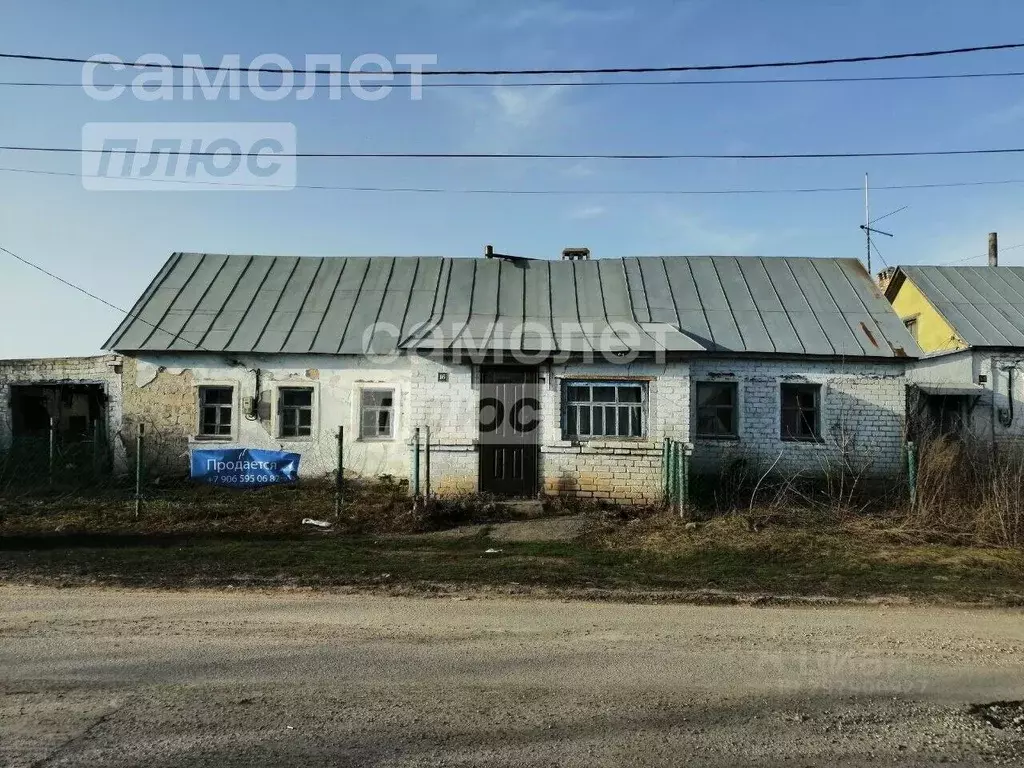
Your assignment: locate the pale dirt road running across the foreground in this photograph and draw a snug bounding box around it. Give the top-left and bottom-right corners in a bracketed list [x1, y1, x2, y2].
[0, 587, 1024, 768]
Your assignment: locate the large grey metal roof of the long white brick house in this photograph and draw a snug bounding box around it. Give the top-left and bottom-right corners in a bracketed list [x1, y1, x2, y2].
[103, 253, 921, 357]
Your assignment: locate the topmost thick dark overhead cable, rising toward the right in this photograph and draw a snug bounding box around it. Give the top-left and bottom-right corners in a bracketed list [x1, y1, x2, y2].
[0, 43, 1024, 77]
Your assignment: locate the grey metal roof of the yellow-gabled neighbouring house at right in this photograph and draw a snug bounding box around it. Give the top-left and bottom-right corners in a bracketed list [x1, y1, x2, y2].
[893, 266, 1024, 347]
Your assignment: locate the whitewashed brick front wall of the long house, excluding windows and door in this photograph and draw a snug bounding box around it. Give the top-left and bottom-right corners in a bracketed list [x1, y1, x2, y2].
[117, 355, 905, 503]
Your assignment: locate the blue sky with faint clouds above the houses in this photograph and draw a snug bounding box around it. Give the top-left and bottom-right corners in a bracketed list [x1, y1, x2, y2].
[0, 0, 1024, 357]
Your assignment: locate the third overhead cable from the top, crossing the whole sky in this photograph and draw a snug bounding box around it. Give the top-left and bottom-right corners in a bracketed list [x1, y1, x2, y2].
[8, 145, 1024, 160]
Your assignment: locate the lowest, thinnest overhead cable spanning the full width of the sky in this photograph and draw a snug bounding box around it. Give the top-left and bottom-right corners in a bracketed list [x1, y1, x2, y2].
[8, 166, 1024, 195]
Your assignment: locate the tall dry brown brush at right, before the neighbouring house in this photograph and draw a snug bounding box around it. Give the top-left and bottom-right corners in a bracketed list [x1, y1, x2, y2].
[903, 437, 1024, 547]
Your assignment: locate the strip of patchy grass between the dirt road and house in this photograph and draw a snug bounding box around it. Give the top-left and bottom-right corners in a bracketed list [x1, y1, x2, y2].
[0, 516, 1024, 604]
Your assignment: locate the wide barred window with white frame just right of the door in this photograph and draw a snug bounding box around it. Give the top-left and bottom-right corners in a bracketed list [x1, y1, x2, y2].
[562, 381, 647, 440]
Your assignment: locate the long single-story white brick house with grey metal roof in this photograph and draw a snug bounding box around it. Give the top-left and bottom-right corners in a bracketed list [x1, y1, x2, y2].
[104, 248, 920, 503]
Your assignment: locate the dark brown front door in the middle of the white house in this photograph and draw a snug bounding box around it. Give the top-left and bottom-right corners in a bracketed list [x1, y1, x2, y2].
[479, 367, 541, 497]
